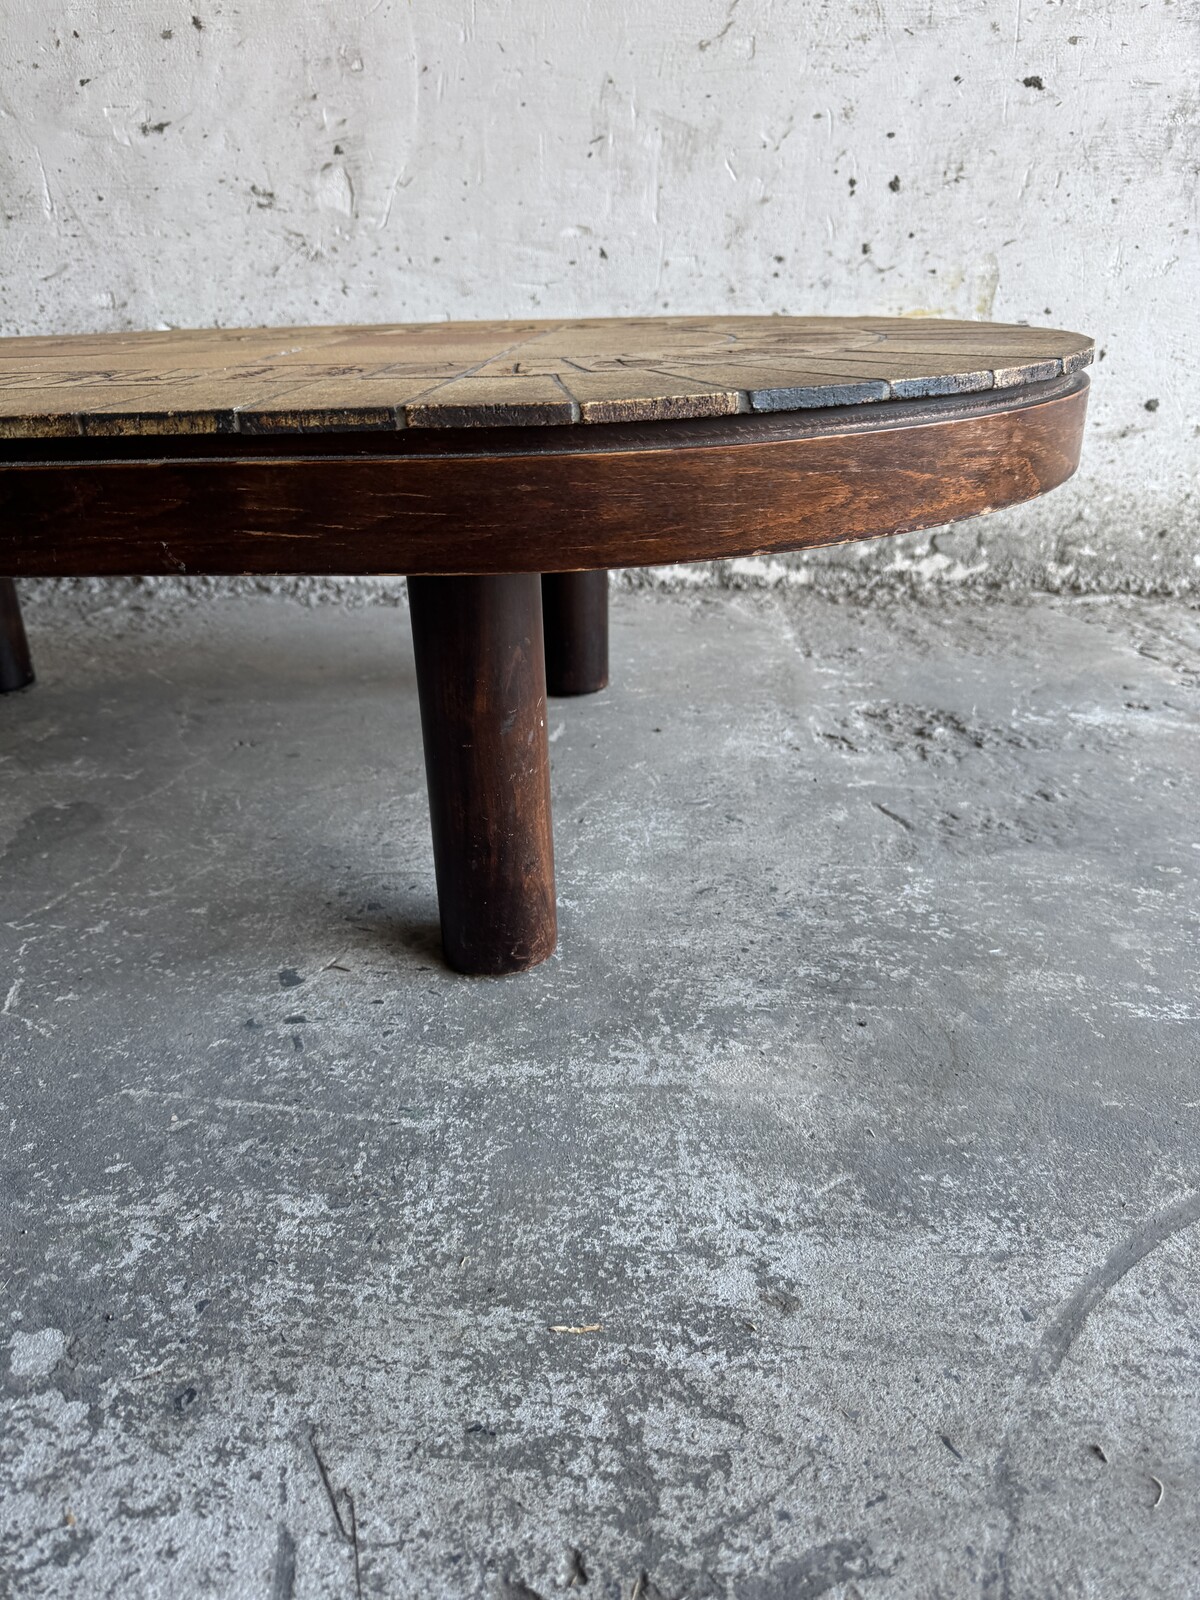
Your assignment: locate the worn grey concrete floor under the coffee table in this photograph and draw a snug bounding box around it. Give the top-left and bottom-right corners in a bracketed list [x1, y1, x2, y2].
[0, 594, 1200, 1600]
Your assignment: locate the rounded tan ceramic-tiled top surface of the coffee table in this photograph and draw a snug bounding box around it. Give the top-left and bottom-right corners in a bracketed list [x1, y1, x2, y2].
[0, 317, 1093, 438]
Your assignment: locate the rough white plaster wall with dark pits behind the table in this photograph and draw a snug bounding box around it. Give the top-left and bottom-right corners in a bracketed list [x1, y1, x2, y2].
[0, 0, 1200, 590]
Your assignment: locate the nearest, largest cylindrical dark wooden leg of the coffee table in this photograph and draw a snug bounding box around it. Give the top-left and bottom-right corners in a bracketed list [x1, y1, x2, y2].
[408, 573, 557, 973]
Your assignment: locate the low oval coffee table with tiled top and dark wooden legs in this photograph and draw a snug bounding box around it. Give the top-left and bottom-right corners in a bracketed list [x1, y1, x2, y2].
[0, 308, 1093, 973]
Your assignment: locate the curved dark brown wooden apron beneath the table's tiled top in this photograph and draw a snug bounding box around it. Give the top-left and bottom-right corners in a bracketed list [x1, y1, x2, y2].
[0, 374, 1086, 578]
